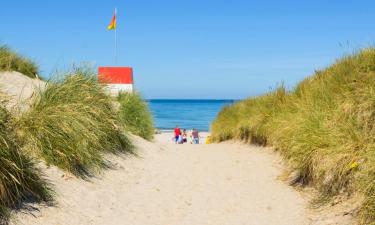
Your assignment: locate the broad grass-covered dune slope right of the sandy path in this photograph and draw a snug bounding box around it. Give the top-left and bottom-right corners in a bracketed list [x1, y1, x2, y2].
[212, 48, 375, 224]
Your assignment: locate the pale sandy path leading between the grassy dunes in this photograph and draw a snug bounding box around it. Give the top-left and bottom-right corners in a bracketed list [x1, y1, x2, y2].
[13, 134, 308, 225]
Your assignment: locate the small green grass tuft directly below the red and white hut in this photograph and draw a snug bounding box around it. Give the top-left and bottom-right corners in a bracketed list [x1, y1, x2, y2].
[117, 93, 154, 140]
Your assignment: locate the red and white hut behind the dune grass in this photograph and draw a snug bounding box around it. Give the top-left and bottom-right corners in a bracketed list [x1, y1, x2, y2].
[98, 66, 134, 96]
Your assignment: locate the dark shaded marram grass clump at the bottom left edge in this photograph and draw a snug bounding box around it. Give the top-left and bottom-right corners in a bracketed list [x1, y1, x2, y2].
[0, 106, 52, 224]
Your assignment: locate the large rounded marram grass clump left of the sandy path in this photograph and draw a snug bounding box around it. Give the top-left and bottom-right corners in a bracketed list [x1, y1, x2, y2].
[17, 69, 132, 177]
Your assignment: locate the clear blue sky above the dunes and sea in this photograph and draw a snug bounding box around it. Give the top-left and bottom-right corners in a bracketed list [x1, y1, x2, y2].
[0, 0, 375, 99]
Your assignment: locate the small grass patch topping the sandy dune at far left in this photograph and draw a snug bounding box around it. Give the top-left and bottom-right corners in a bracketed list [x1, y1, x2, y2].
[0, 45, 38, 78]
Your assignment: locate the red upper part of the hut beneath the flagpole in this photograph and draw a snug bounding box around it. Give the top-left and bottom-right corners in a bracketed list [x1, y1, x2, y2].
[98, 66, 133, 84]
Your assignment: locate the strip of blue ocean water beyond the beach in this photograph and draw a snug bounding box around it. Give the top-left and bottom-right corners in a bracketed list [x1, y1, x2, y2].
[148, 99, 234, 131]
